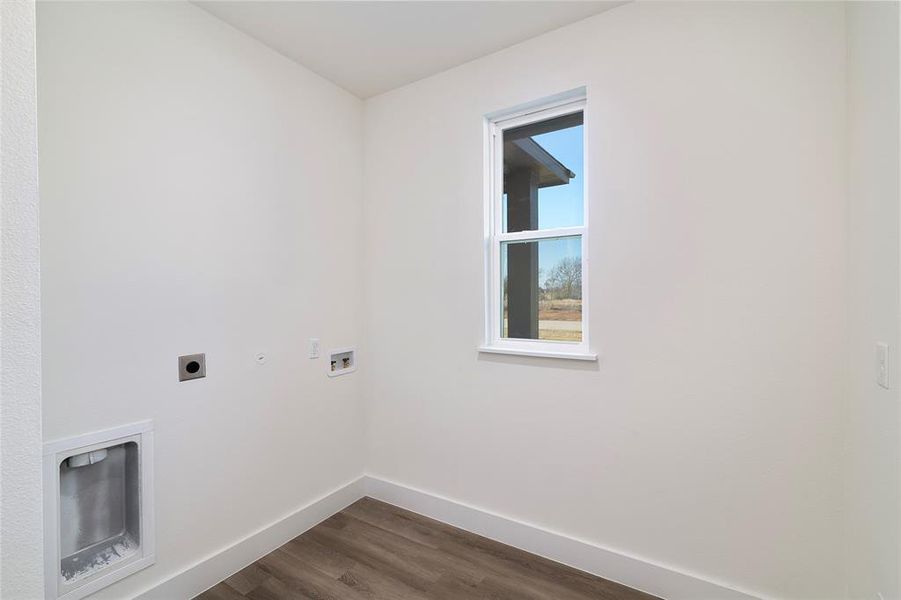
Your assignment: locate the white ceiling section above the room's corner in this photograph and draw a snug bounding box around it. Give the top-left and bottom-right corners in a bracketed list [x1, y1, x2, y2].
[196, 0, 623, 98]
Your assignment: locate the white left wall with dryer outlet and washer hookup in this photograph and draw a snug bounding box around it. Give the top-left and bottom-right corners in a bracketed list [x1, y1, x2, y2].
[38, 2, 363, 598]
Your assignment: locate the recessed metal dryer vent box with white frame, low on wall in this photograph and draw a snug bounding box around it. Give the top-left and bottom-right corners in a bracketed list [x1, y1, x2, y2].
[44, 421, 154, 600]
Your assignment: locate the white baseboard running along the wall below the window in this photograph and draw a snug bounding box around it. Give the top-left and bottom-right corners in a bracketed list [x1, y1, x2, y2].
[363, 475, 761, 600]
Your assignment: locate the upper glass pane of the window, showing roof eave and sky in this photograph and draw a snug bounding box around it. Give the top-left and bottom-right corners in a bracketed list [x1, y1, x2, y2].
[501, 112, 584, 232]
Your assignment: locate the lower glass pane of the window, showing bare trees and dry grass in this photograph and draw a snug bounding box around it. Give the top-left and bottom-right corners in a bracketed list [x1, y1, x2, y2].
[501, 235, 582, 342]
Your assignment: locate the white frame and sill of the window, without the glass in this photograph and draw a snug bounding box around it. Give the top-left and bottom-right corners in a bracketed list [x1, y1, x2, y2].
[479, 91, 597, 360]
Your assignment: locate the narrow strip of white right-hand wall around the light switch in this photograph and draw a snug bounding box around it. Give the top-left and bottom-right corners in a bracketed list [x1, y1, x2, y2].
[846, 2, 901, 599]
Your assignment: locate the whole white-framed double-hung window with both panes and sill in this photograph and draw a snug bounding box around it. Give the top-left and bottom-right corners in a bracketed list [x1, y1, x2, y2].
[481, 91, 596, 360]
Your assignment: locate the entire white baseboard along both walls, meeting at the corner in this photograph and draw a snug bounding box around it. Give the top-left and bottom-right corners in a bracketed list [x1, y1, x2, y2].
[137, 475, 762, 600]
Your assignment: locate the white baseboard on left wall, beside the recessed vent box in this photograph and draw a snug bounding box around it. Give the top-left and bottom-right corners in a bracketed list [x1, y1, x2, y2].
[137, 477, 365, 600]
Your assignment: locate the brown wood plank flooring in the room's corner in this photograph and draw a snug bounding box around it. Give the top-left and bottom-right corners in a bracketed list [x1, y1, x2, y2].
[197, 498, 655, 600]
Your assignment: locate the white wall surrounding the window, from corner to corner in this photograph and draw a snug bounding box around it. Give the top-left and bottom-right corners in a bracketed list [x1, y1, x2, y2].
[363, 3, 847, 600]
